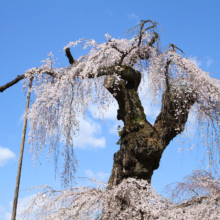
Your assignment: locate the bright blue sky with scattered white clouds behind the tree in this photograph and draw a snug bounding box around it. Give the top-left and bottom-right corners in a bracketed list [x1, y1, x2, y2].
[0, 0, 220, 220]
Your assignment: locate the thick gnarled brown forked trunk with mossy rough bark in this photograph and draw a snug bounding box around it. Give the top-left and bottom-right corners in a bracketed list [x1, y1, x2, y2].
[104, 66, 196, 187]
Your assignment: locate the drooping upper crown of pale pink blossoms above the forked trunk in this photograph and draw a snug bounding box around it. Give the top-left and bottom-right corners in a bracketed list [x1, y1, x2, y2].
[10, 20, 220, 185]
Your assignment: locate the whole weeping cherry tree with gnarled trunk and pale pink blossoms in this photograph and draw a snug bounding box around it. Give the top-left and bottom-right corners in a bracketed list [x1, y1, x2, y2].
[0, 20, 220, 219]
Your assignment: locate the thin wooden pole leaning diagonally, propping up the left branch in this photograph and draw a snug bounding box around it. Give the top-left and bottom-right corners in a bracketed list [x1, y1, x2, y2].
[11, 78, 33, 220]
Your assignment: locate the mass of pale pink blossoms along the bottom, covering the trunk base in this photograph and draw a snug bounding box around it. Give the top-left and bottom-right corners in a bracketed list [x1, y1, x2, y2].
[20, 171, 220, 220]
